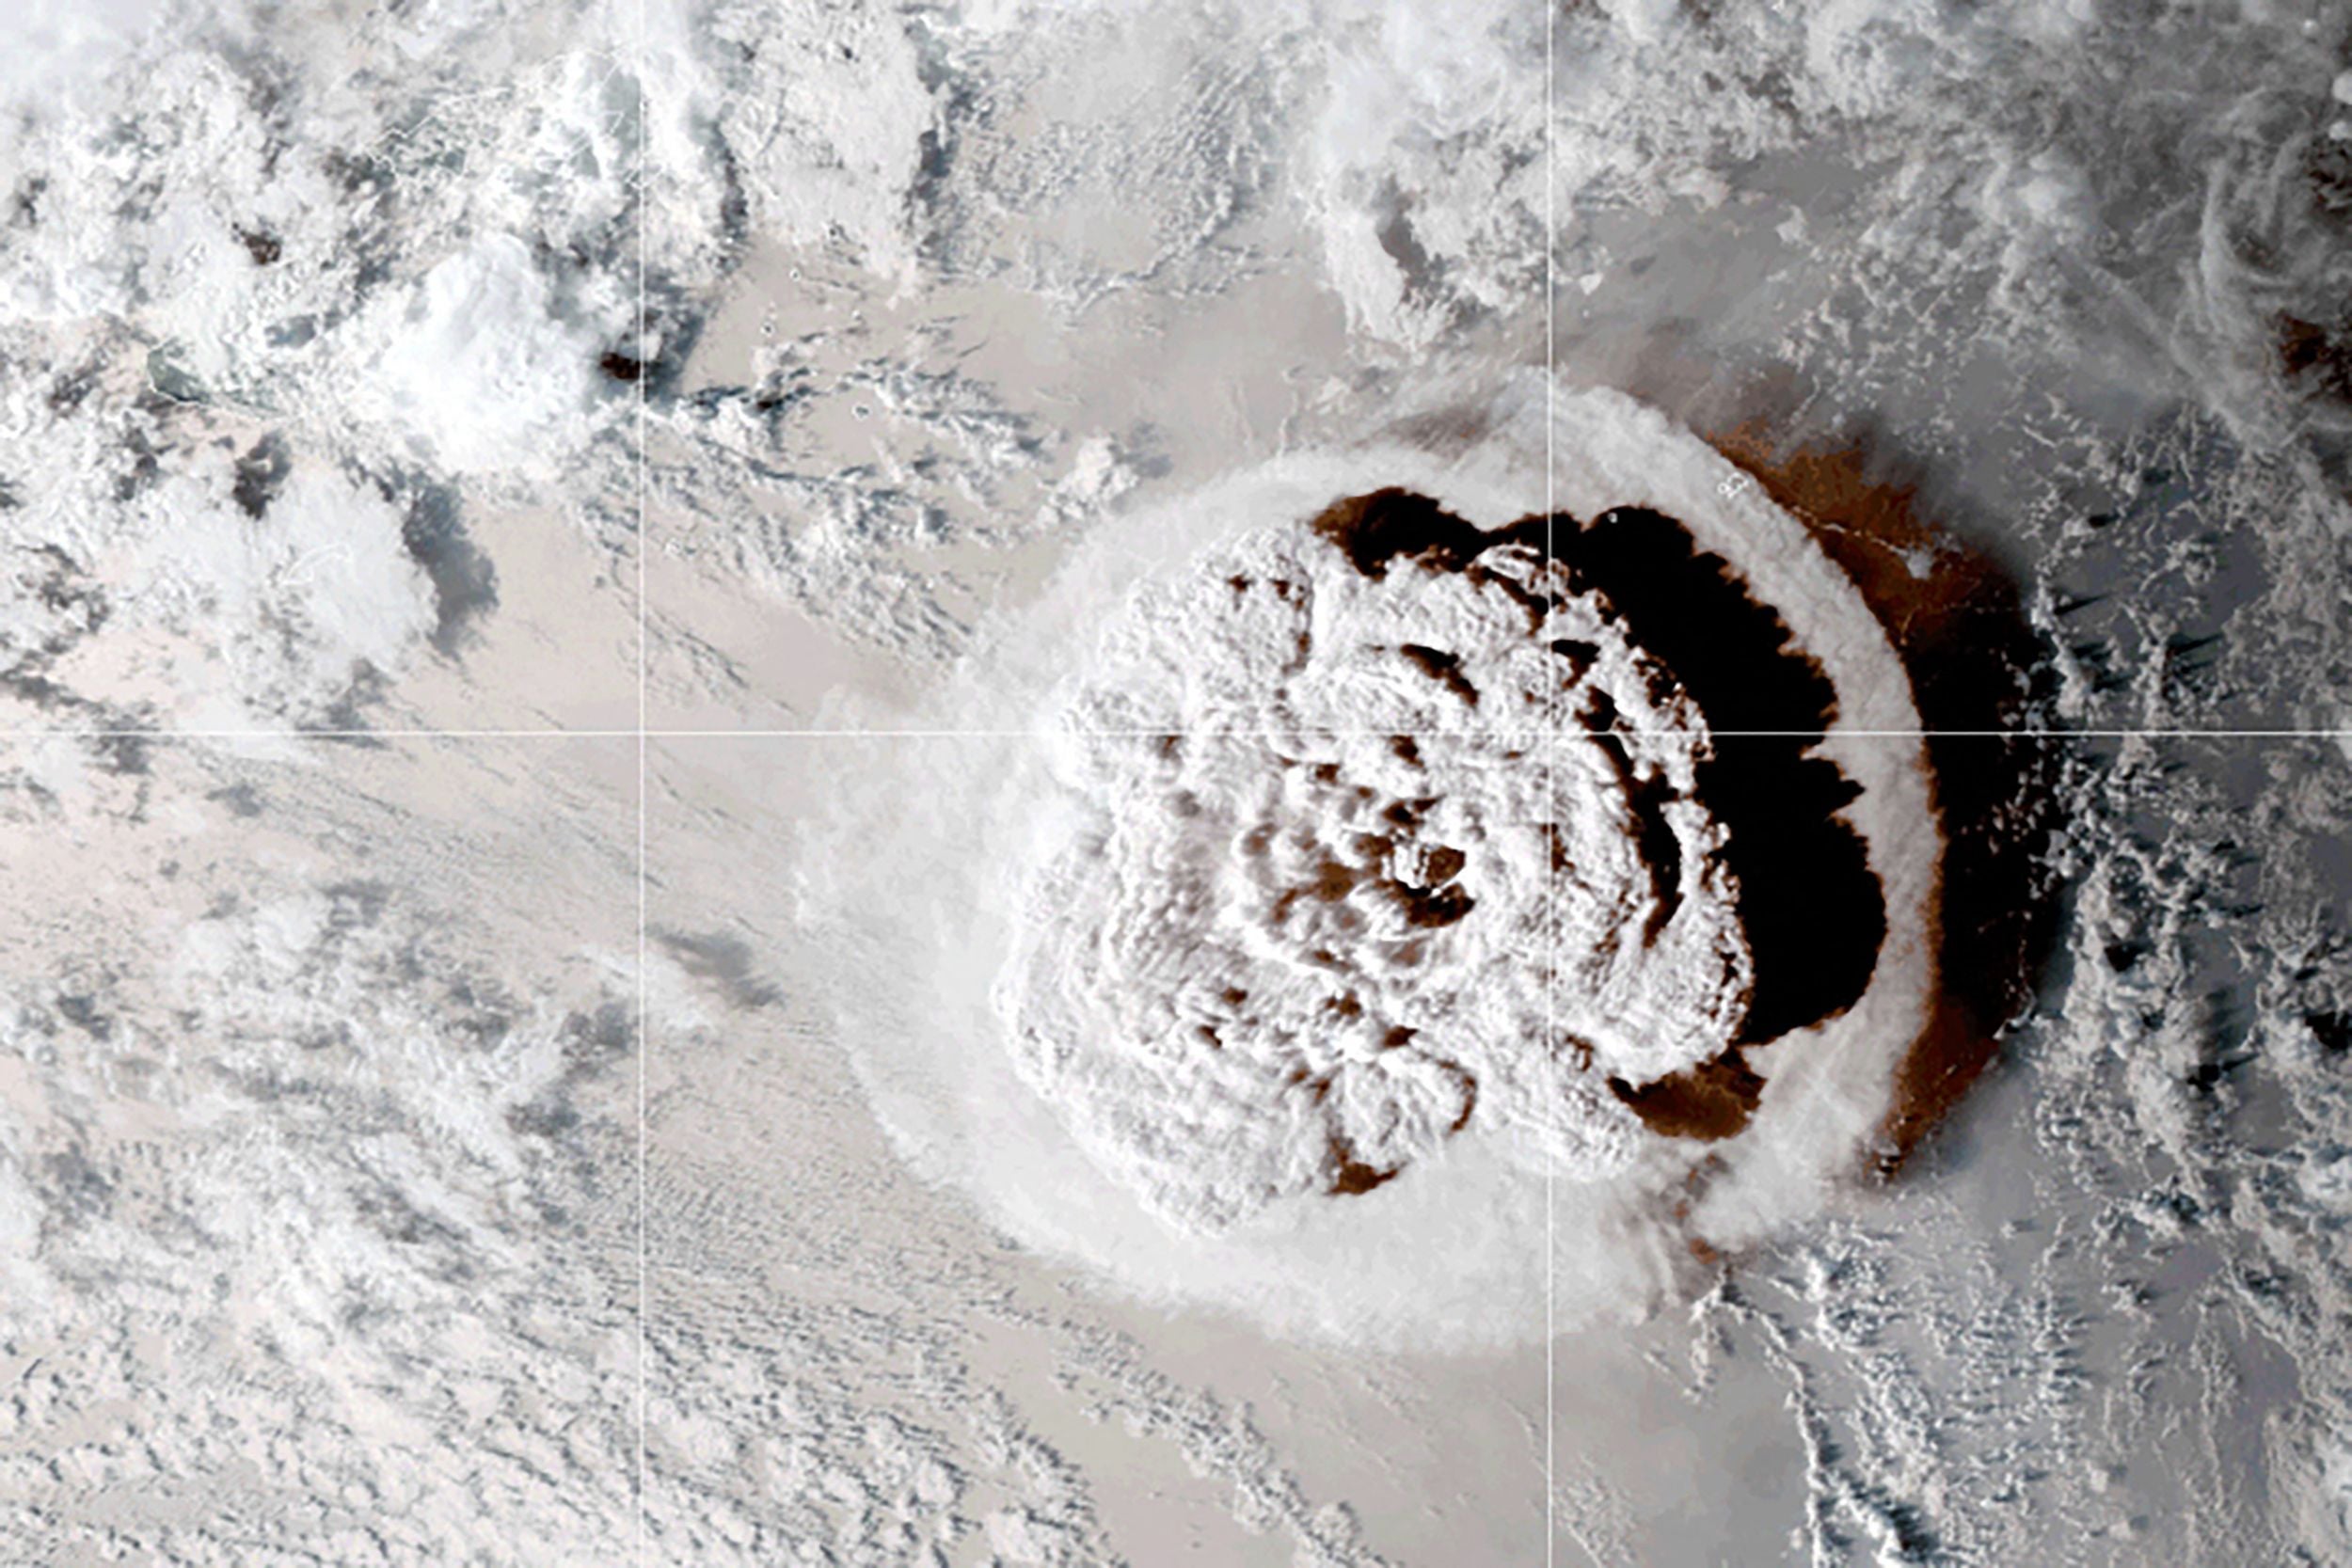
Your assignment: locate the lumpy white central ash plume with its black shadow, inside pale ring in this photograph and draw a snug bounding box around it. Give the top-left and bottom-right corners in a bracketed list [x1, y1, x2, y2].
[1002, 489, 1884, 1232]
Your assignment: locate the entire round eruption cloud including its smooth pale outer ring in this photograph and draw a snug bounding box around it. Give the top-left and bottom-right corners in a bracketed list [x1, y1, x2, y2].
[807, 383, 2023, 1345]
